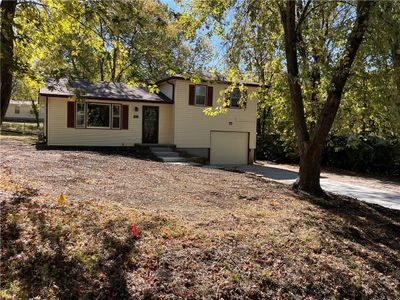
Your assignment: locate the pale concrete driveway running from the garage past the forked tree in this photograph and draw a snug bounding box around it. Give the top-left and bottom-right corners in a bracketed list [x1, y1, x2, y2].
[234, 165, 400, 210]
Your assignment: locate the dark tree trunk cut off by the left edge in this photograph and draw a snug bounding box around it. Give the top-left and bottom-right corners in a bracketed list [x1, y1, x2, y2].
[0, 0, 17, 125]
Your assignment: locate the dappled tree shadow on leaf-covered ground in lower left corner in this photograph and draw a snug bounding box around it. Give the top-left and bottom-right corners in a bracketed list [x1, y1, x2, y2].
[1, 189, 136, 299]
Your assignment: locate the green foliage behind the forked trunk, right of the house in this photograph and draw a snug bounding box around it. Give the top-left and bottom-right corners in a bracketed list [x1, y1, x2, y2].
[182, 0, 400, 178]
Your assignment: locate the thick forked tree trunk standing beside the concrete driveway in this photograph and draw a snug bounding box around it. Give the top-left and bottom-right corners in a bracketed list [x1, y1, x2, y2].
[281, 0, 375, 195]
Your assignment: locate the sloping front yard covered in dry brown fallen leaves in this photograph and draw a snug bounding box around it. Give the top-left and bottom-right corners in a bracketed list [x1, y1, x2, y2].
[0, 137, 400, 299]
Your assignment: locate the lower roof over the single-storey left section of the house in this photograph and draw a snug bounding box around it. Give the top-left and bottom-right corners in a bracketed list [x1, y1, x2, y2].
[39, 78, 173, 103]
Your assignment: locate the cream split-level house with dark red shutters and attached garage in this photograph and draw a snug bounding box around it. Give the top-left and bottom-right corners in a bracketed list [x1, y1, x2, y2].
[39, 75, 258, 164]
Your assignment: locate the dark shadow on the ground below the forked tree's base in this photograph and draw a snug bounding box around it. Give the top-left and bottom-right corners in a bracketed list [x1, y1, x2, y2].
[291, 191, 400, 277]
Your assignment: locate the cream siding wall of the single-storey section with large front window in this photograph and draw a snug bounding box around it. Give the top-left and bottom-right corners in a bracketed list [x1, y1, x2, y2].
[47, 97, 172, 146]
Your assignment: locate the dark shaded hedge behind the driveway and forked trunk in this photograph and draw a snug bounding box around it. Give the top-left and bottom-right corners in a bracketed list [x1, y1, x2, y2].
[257, 134, 400, 176]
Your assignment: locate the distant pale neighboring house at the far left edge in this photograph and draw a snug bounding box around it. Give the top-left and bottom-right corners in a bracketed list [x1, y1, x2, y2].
[4, 100, 43, 122]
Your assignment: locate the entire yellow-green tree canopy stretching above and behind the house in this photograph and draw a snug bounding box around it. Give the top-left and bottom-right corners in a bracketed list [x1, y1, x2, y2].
[2, 0, 400, 190]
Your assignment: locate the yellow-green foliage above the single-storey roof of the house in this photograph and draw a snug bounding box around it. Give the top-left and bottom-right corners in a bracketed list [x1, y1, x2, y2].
[9, 0, 210, 99]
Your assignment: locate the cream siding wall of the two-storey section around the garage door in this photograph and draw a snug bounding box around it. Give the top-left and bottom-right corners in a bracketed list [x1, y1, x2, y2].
[173, 80, 257, 149]
